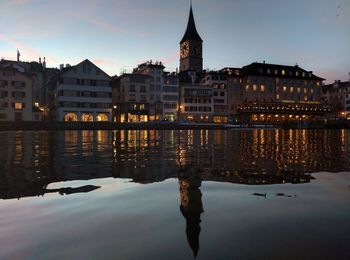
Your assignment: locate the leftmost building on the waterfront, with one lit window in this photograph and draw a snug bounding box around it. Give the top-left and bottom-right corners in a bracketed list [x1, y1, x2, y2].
[0, 67, 34, 122]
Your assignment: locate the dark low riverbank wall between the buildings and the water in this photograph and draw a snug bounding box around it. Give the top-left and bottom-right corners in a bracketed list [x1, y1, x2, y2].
[0, 122, 350, 131]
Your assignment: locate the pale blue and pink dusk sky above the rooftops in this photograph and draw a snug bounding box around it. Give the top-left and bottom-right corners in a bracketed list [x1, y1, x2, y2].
[0, 0, 350, 82]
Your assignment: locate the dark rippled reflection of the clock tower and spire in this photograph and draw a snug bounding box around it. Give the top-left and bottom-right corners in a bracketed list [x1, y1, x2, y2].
[179, 170, 203, 256]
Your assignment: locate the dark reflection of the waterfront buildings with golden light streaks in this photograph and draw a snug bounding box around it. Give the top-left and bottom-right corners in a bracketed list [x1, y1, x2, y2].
[0, 130, 350, 201]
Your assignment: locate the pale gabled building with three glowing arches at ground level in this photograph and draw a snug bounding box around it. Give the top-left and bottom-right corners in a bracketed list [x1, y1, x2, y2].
[50, 60, 112, 122]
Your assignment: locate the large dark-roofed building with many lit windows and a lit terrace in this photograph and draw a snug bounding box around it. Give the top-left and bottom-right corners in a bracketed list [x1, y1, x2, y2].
[237, 62, 329, 124]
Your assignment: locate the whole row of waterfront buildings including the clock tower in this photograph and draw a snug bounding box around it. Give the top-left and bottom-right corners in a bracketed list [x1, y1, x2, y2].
[0, 7, 350, 124]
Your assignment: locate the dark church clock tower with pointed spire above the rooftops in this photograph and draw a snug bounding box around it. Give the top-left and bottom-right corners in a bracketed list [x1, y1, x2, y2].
[180, 4, 203, 73]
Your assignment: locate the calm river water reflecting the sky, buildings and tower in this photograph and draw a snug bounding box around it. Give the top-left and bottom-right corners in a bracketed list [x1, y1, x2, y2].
[0, 129, 350, 259]
